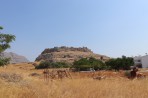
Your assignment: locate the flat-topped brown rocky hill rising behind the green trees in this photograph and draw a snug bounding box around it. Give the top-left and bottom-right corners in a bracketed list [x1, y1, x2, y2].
[36, 46, 110, 63]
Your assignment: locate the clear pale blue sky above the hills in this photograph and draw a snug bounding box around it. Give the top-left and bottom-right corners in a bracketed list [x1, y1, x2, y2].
[0, 0, 148, 61]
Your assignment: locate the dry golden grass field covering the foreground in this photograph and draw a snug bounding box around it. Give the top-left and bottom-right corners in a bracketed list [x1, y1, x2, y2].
[0, 63, 148, 98]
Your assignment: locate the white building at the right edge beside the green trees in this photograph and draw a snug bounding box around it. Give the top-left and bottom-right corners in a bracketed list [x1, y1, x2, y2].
[134, 55, 148, 68]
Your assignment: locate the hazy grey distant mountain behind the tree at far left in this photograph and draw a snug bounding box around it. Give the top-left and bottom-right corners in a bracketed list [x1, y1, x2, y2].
[0, 52, 29, 63]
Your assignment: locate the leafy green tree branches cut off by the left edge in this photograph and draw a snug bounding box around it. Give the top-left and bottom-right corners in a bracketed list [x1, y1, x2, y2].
[0, 26, 15, 66]
